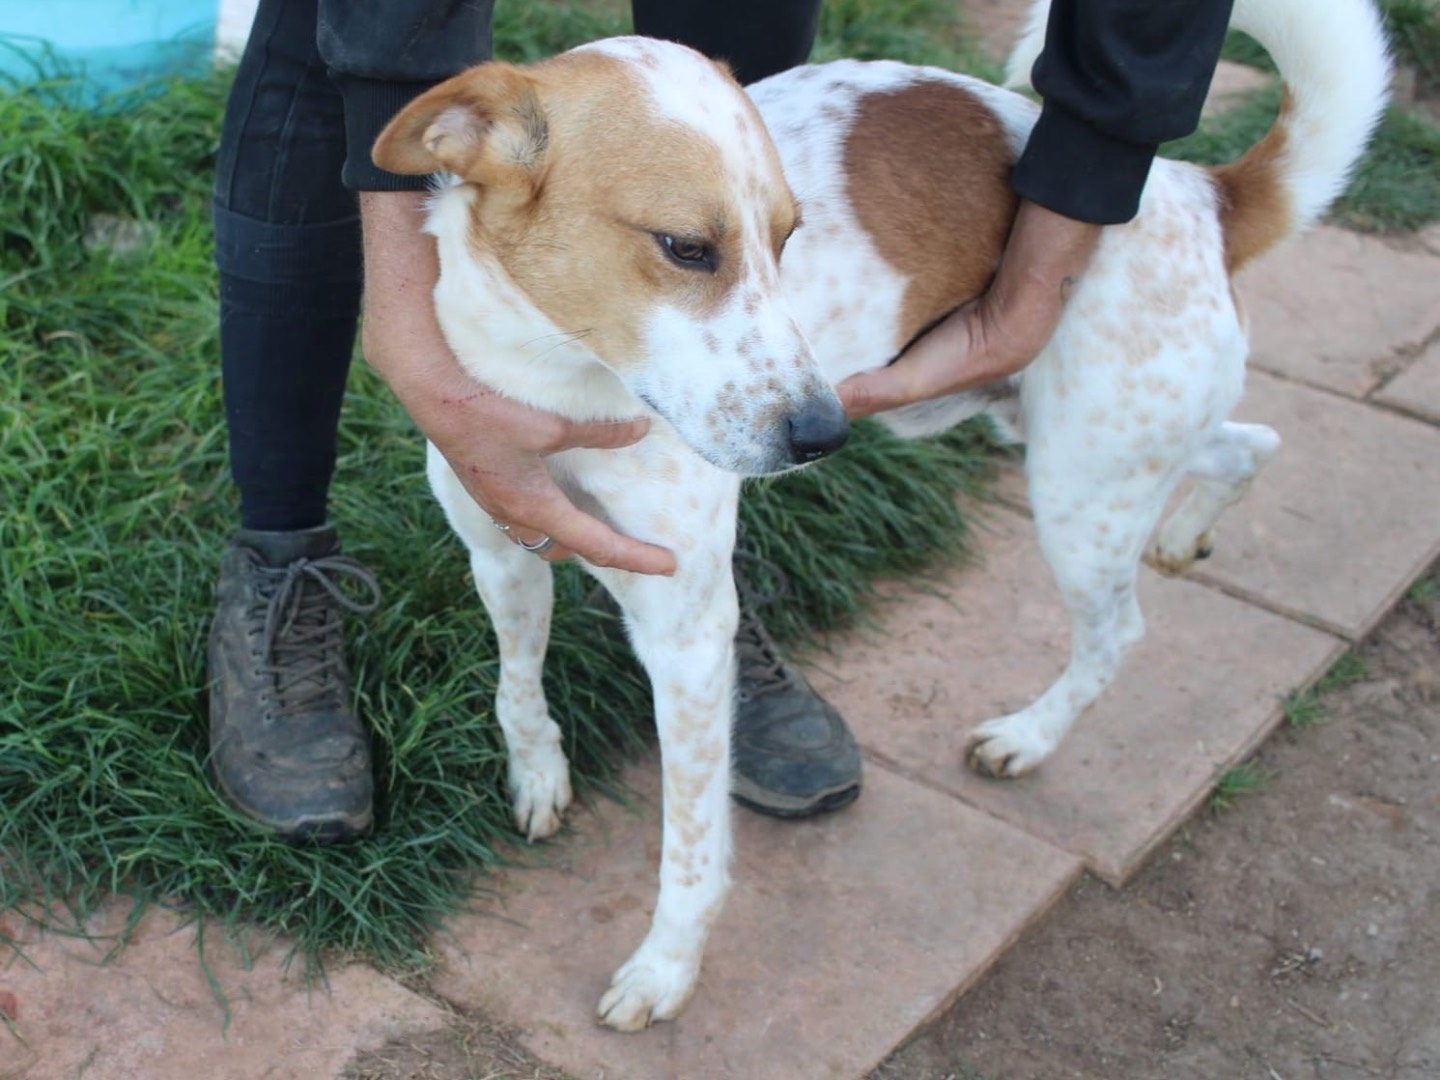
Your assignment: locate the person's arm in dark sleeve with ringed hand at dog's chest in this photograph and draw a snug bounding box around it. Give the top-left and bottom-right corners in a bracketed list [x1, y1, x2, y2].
[318, 0, 675, 573]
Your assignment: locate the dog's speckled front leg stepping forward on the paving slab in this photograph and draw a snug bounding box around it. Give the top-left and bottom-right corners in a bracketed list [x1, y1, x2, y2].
[587, 552, 739, 1031]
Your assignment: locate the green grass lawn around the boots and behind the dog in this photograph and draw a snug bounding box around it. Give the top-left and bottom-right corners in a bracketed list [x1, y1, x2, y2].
[0, 0, 1440, 968]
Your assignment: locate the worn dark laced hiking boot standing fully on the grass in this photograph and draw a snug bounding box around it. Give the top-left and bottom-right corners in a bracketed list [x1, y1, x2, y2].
[207, 526, 380, 841]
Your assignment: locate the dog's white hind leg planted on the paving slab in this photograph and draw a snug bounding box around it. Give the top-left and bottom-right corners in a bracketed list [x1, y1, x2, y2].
[965, 445, 1179, 776]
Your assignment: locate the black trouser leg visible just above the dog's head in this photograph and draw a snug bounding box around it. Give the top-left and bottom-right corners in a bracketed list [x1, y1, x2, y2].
[631, 0, 821, 84]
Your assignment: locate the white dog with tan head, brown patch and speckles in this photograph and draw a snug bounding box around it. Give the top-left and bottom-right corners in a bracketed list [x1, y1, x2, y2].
[373, 0, 1388, 1031]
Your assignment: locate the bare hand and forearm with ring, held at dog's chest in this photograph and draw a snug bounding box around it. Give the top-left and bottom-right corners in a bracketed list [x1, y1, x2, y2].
[360, 192, 675, 575]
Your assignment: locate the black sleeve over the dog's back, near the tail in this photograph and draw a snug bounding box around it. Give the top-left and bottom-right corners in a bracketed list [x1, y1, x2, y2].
[1014, 0, 1233, 225]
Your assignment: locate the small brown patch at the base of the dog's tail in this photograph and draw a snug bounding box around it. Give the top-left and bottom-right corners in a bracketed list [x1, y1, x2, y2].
[1211, 91, 1293, 274]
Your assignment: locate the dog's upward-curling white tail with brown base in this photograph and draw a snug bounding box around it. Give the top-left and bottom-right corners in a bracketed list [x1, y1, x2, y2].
[1005, 0, 1390, 272]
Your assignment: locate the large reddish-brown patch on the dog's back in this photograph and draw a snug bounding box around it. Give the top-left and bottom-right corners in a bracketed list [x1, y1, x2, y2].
[845, 79, 1017, 341]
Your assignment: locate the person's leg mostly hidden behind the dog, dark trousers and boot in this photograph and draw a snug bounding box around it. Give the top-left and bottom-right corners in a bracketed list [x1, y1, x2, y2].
[632, 0, 861, 818]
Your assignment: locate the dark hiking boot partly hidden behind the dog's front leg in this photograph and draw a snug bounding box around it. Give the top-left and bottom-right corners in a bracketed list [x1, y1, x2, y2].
[730, 547, 861, 818]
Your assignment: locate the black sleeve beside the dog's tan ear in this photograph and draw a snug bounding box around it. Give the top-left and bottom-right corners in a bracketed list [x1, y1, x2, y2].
[315, 0, 494, 192]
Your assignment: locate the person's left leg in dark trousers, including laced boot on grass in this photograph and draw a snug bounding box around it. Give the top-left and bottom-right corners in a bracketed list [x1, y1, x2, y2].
[209, 0, 374, 840]
